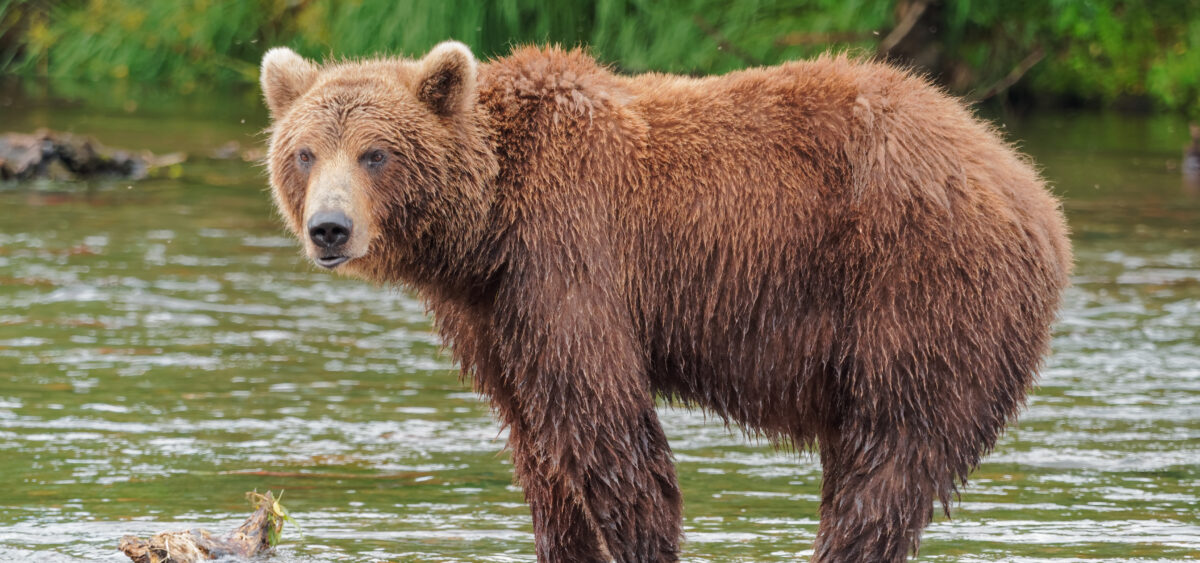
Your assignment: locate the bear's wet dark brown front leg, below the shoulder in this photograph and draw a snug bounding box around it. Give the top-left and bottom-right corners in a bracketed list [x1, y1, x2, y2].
[493, 286, 682, 563]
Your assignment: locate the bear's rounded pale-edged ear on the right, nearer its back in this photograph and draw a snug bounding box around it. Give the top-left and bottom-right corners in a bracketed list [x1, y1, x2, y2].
[416, 41, 476, 115]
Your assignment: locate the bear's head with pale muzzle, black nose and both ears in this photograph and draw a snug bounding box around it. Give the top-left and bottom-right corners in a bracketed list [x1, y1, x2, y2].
[260, 42, 497, 282]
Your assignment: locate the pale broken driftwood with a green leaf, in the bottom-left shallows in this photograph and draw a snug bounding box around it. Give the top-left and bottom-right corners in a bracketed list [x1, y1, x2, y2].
[118, 492, 295, 563]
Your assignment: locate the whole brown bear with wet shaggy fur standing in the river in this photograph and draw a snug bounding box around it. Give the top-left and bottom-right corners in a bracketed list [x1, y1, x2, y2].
[262, 42, 1072, 562]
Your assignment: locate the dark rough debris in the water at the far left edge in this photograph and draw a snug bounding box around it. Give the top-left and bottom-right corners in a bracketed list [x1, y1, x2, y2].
[0, 130, 186, 180]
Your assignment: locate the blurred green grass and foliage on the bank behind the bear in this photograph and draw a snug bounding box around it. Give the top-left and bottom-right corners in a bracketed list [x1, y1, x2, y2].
[0, 0, 1200, 116]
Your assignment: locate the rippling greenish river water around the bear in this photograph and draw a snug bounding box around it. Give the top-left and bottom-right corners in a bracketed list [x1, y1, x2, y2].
[0, 104, 1200, 562]
